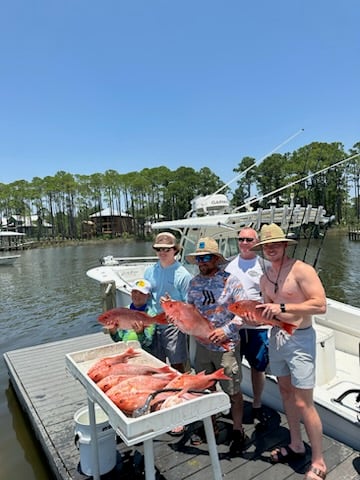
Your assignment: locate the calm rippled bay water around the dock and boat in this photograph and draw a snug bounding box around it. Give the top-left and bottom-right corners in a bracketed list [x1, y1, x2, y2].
[0, 231, 360, 480]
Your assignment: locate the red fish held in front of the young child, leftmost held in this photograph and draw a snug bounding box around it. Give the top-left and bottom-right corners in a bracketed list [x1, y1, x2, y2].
[98, 307, 168, 330]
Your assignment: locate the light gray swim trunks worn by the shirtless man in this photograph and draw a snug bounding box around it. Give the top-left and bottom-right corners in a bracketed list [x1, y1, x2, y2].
[269, 327, 316, 389]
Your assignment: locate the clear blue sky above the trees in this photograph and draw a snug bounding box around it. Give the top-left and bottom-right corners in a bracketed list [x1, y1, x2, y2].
[0, 0, 360, 191]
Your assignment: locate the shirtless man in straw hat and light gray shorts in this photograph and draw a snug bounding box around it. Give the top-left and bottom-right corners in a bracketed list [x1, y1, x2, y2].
[248, 224, 326, 480]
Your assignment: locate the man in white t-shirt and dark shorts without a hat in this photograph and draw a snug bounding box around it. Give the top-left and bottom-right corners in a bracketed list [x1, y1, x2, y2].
[225, 227, 271, 429]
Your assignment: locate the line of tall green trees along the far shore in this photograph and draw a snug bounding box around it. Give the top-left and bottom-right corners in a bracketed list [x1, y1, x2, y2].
[0, 142, 360, 239]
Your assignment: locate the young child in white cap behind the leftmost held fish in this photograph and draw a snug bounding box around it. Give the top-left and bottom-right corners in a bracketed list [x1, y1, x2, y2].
[109, 278, 155, 351]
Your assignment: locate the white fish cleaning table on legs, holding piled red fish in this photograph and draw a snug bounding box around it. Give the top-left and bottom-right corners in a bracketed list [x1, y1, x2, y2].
[66, 342, 230, 480]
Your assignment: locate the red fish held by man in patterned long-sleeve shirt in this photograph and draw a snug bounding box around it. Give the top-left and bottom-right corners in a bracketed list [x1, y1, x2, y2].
[161, 299, 230, 350]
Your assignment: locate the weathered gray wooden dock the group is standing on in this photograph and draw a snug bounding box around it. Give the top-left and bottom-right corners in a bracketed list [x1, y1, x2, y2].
[4, 333, 360, 480]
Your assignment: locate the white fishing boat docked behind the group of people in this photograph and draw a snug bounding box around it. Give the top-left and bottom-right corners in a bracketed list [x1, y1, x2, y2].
[86, 195, 360, 450]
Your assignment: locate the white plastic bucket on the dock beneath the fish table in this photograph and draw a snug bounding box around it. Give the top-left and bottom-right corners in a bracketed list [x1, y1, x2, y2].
[74, 404, 116, 476]
